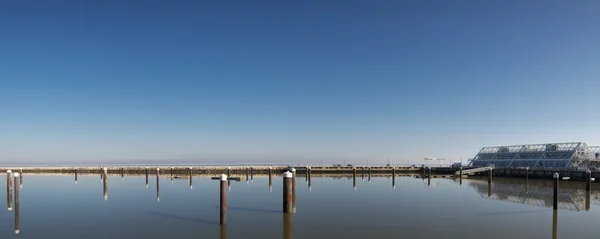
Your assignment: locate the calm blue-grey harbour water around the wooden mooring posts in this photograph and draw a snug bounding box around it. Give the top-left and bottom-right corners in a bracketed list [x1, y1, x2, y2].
[0, 174, 600, 239]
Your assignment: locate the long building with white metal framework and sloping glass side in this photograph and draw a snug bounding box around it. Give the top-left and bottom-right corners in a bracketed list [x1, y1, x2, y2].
[471, 142, 600, 170]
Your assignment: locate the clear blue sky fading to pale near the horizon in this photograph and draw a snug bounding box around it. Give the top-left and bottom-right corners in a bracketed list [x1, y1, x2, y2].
[0, 0, 600, 164]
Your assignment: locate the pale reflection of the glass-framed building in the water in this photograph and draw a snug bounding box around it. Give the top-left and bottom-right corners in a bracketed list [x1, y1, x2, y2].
[465, 178, 600, 211]
